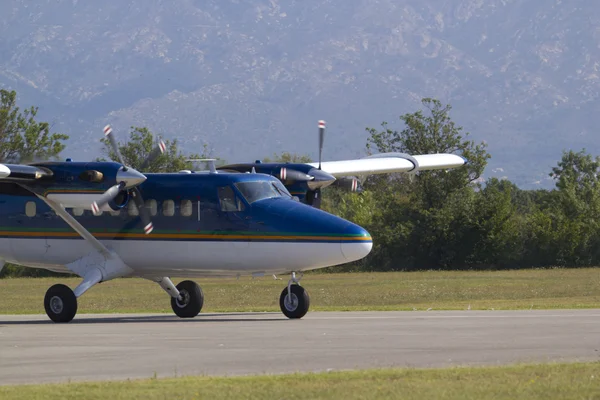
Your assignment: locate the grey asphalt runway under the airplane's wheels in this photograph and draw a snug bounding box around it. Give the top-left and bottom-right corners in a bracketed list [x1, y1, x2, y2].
[0, 310, 600, 384]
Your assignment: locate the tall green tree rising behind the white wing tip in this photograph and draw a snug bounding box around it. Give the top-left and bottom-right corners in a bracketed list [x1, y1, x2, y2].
[366, 98, 490, 269]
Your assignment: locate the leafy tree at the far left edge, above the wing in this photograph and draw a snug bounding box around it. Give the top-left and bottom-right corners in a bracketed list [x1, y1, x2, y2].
[0, 89, 69, 163]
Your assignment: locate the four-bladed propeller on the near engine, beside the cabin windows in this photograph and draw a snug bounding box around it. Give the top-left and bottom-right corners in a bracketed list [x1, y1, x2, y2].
[91, 125, 166, 235]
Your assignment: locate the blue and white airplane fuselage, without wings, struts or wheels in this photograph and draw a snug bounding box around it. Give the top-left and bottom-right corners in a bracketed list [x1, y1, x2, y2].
[0, 169, 372, 277]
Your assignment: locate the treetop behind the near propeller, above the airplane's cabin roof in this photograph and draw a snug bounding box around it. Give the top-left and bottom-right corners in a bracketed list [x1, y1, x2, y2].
[102, 126, 206, 172]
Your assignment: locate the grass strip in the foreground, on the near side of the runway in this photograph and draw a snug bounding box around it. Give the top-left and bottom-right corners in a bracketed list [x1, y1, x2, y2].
[0, 363, 600, 400]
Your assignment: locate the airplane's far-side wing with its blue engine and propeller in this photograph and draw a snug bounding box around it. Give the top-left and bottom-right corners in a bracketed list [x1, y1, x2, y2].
[217, 120, 467, 208]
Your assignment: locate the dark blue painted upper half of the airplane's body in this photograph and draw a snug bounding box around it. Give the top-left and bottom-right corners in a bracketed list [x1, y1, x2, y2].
[0, 163, 370, 241]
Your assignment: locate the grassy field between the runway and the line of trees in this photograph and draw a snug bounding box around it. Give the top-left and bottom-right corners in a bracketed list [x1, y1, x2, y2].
[0, 268, 600, 314]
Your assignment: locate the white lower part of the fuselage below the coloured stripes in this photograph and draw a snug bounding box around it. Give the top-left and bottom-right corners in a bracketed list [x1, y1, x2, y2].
[0, 238, 372, 277]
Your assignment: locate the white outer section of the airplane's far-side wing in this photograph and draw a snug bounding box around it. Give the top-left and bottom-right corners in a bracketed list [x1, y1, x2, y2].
[310, 153, 467, 177]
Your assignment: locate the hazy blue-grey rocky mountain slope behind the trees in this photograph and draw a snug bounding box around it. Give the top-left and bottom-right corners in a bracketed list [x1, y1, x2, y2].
[0, 0, 600, 187]
